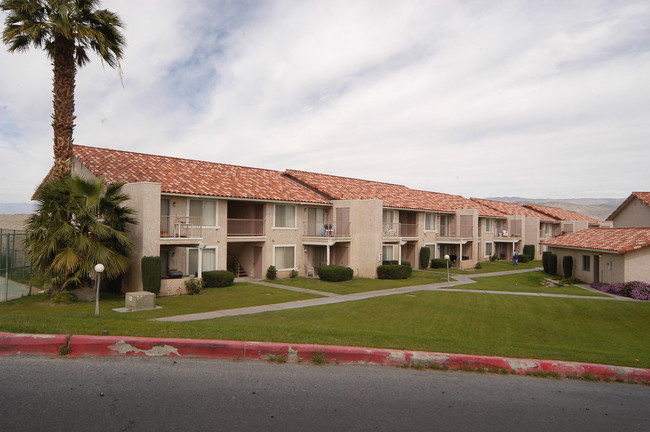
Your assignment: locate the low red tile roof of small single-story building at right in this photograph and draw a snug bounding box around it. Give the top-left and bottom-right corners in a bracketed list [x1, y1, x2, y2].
[542, 228, 650, 254]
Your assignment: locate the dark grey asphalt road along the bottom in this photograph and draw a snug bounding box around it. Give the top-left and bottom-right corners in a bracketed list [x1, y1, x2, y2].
[0, 356, 650, 432]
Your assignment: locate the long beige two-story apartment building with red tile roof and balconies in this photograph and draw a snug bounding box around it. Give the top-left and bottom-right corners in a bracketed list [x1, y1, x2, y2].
[62, 146, 604, 294]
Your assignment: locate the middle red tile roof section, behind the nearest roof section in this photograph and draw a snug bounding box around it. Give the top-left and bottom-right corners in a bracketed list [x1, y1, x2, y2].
[284, 170, 505, 218]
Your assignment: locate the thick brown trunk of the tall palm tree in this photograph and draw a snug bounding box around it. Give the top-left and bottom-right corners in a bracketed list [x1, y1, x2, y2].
[52, 34, 77, 179]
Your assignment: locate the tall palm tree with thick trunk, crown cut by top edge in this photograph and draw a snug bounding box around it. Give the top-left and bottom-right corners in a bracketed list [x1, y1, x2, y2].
[0, 0, 125, 178]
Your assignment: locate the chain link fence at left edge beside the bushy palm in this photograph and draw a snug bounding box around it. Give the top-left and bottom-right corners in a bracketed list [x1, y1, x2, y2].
[0, 228, 32, 302]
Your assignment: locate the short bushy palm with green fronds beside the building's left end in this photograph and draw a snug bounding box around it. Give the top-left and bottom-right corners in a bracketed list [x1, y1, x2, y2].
[25, 175, 137, 294]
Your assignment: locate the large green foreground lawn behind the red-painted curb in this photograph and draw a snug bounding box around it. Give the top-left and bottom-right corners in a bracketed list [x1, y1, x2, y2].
[0, 272, 650, 368]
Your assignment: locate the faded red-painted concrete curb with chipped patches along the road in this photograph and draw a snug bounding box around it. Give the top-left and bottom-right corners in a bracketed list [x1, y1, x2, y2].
[0, 333, 650, 384]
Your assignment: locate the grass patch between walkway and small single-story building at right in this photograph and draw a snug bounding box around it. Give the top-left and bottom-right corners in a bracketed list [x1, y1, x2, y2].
[454, 271, 608, 297]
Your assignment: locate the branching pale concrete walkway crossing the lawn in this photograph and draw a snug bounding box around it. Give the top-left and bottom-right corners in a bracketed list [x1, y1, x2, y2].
[153, 268, 634, 322]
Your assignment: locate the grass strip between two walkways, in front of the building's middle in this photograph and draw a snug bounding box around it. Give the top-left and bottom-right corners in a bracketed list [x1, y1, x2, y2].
[266, 270, 447, 295]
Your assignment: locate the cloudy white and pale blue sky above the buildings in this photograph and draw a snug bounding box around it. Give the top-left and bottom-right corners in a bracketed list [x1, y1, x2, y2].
[0, 0, 650, 203]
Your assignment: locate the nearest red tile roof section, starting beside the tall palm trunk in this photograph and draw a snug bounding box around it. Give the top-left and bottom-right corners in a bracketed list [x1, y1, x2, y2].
[73, 145, 330, 204]
